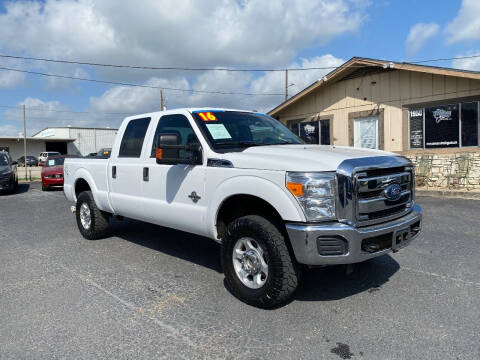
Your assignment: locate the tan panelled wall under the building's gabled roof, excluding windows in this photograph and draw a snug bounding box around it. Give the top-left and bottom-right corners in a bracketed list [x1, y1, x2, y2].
[274, 70, 480, 151]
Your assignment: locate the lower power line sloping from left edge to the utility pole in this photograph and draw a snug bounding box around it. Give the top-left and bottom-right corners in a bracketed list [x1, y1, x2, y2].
[0, 67, 283, 96]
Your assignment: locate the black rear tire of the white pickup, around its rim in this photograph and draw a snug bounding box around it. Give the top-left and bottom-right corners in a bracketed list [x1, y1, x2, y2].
[75, 191, 110, 240]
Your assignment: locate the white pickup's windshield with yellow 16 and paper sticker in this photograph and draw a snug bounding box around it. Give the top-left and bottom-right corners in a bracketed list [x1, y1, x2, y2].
[192, 110, 303, 149]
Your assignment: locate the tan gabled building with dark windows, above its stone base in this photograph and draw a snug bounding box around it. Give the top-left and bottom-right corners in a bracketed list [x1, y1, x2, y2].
[269, 57, 480, 153]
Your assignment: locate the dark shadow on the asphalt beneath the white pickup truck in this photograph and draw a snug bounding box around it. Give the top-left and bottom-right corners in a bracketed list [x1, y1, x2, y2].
[112, 219, 400, 307]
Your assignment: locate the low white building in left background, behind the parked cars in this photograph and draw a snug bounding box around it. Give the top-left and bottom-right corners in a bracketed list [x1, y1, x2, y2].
[0, 126, 118, 159]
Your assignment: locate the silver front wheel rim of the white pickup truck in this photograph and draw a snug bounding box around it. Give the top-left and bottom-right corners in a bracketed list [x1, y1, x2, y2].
[232, 237, 268, 289]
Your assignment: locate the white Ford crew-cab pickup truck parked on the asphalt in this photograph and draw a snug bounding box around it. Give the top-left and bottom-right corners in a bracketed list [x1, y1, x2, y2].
[64, 108, 422, 307]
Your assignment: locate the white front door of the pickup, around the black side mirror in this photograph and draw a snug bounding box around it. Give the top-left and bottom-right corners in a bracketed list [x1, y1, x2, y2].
[139, 112, 208, 235]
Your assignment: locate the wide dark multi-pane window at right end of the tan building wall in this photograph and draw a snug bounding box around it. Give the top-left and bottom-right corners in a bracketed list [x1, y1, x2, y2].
[409, 102, 479, 149]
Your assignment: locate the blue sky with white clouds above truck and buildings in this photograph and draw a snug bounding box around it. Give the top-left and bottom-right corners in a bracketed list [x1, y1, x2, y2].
[0, 0, 480, 136]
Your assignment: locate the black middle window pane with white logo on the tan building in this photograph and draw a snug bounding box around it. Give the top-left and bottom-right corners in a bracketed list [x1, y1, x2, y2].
[425, 105, 460, 148]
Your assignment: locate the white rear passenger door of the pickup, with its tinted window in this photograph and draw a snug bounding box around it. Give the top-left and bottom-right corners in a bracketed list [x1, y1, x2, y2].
[107, 117, 151, 219]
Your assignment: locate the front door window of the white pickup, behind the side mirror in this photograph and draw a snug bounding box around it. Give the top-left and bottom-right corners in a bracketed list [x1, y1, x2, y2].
[151, 114, 199, 158]
